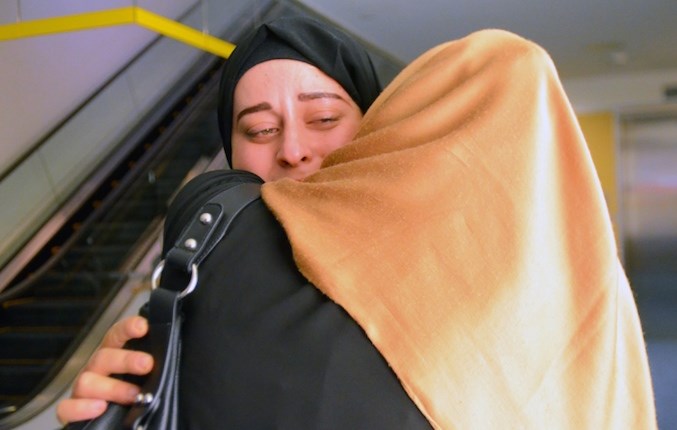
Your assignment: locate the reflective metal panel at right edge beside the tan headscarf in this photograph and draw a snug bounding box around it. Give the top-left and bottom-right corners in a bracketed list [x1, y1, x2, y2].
[618, 106, 677, 429]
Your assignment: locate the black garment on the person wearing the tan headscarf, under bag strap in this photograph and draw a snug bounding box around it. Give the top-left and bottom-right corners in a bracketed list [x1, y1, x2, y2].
[165, 171, 430, 430]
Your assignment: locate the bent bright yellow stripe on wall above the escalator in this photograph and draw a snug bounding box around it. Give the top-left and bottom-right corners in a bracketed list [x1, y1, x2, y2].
[0, 6, 235, 58]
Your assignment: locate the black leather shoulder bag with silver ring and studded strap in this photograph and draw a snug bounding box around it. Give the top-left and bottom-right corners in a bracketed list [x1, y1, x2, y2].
[66, 183, 261, 430]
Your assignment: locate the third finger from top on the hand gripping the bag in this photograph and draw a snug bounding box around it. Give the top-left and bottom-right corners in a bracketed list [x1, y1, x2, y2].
[71, 372, 140, 405]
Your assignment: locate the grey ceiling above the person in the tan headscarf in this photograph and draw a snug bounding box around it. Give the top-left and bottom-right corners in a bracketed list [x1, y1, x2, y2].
[300, 0, 677, 79]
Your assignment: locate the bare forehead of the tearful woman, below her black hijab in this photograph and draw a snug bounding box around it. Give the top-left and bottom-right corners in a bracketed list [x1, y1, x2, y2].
[233, 59, 351, 105]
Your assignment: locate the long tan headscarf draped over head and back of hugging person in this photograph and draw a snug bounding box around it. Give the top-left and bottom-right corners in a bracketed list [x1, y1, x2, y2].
[263, 30, 656, 429]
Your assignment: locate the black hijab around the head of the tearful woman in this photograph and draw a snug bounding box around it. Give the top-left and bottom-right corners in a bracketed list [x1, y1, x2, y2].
[218, 16, 382, 163]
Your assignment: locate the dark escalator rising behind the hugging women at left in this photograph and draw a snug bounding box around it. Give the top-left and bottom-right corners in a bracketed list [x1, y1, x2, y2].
[0, 58, 227, 428]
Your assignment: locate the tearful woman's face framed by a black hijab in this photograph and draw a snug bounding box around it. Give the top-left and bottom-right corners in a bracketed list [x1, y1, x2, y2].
[232, 60, 362, 181]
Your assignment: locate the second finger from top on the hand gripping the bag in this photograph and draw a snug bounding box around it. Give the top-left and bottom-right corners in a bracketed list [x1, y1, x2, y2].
[84, 348, 153, 376]
